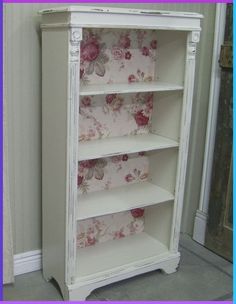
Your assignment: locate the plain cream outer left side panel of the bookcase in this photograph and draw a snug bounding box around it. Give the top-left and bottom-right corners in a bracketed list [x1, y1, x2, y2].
[42, 29, 76, 294]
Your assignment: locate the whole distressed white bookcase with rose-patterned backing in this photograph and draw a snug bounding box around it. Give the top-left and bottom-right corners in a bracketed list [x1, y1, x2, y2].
[40, 6, 202, 300]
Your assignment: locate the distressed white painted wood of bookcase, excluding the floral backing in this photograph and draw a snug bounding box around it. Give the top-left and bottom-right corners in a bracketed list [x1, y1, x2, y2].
[41, 6, 202, 300]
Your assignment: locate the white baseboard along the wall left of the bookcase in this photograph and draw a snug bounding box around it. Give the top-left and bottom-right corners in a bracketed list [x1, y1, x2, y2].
[14, 250, 42, 276]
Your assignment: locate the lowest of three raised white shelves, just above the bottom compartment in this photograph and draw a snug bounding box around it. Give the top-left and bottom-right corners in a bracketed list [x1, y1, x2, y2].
[77, 182, 174, 220]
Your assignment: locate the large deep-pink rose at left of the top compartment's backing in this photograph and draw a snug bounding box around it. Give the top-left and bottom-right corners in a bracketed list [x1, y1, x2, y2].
[81, 37, 100, 62]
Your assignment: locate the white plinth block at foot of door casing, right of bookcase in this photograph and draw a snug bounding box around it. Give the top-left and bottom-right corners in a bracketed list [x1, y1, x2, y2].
[193, 210, 207, 245]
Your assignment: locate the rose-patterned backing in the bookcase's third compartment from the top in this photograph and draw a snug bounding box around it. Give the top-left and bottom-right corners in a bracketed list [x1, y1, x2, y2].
[78, 152, 149, 194]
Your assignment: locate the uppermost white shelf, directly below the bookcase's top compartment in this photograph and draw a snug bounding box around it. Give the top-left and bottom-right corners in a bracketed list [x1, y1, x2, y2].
[80, 81, 183, 96]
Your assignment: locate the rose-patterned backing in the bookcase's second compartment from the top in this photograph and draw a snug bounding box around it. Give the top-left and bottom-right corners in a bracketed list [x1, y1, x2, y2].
[79, 93, 153, 141]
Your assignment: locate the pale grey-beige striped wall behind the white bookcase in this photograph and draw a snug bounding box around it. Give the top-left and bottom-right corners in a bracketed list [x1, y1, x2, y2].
[4, 3, 215, 253]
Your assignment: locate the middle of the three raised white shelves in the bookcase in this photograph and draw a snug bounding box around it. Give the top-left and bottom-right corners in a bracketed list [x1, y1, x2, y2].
[79, 133, 179, 161]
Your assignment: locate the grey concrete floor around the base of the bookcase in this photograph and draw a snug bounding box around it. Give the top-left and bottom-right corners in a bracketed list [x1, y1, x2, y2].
[4, 235, 233, 301]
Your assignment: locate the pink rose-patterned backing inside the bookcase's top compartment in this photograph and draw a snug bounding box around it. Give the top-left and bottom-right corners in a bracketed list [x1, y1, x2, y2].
[80, 29, 157, 84]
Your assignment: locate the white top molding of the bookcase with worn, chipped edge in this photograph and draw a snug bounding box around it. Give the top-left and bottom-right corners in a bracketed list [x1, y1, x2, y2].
[39, 6, 203, 31]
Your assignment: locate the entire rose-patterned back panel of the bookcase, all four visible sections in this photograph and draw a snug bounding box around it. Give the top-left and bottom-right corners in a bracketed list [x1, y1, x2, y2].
[77, 29, 157, 248]
